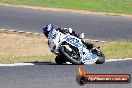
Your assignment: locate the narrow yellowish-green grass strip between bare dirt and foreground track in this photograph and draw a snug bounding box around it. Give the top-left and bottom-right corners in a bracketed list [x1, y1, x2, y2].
[0, 54, 55, 64]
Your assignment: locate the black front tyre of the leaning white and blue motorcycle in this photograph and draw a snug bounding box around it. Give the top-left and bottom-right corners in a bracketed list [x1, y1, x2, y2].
[59, 46, 82, 65]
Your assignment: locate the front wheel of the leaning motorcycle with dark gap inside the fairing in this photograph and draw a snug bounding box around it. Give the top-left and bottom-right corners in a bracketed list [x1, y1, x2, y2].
[60, 46, 82, 64]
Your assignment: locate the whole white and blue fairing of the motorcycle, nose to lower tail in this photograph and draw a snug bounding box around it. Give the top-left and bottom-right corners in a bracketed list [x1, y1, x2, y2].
[48, 24, 97, 64]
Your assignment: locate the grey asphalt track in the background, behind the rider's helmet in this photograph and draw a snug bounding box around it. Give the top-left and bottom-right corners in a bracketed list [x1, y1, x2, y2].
[0, 6, 132, 41]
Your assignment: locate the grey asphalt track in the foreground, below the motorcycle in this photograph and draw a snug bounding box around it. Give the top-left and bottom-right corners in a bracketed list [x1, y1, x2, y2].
[0, 60, 132, 88]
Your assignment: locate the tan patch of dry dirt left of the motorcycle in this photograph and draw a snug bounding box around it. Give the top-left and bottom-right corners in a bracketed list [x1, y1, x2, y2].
[0, 30, 51, 57]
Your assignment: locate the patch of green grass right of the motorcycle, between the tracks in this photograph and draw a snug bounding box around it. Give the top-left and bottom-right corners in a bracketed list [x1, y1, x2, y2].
[95, 42, 132, 59]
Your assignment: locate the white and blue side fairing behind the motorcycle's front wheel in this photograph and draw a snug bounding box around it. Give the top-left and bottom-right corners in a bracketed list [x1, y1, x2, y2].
[63, 35, 97, 64]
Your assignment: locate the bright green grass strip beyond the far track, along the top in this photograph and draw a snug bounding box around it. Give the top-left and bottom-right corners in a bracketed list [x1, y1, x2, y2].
[0, 0, 132, 14]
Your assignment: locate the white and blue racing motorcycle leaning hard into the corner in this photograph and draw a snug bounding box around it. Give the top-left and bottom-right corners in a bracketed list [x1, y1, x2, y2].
[43, 25, 105, 65]
